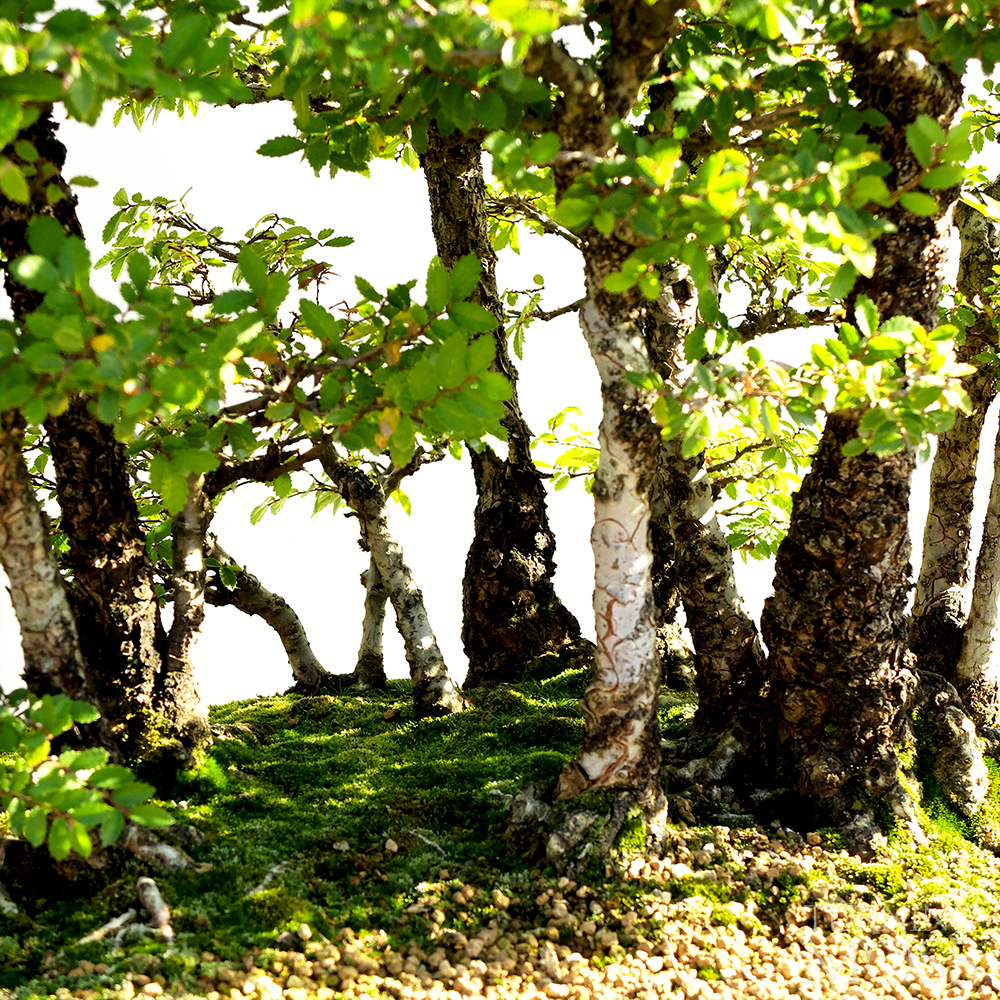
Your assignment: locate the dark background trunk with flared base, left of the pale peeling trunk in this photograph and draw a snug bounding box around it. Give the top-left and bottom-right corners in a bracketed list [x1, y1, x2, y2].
[423, 125, 580, 687]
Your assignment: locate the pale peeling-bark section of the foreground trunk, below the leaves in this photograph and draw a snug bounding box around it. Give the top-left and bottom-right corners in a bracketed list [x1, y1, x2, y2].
[557, 246, 660, 798]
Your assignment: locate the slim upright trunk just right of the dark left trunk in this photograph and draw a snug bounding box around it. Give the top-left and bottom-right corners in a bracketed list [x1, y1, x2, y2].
[157, 474, 212, 746]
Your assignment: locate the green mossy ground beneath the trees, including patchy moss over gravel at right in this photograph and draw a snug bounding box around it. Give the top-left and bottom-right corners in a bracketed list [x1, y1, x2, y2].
[0, 670, 1000, 1000]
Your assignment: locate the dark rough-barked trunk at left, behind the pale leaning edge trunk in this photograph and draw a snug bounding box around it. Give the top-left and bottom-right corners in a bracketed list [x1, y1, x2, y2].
[0, 111, 204, 757]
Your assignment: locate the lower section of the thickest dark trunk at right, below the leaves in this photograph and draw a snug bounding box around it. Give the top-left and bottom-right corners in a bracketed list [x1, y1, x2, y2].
[761, 414, 917, 802]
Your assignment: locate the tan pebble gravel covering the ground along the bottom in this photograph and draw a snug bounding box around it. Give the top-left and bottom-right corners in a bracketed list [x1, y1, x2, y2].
[48, 827, 1000, 1000]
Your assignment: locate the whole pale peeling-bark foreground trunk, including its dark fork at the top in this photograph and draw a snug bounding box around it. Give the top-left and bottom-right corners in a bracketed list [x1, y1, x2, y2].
[525, 0, 681, 800]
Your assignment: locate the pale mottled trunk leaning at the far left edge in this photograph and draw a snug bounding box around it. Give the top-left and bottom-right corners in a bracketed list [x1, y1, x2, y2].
[0, 411, 87, 698]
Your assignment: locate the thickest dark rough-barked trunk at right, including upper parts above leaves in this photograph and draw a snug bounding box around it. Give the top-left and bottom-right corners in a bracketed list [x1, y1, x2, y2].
[762, 27, 961, 850]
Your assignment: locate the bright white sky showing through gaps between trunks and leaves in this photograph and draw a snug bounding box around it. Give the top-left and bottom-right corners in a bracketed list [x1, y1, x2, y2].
[0, 92, 992, 704]
